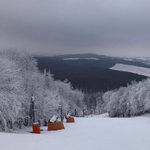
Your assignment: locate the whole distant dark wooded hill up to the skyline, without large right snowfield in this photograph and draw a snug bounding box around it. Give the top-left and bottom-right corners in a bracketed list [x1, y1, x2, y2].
[34, 54, 150, 92]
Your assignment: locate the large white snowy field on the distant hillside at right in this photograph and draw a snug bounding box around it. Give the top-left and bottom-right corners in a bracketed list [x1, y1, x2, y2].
[110, 64, 150, 77]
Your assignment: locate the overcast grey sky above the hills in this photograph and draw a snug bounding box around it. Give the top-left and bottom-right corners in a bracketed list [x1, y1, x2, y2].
[0, 0, 150, 57]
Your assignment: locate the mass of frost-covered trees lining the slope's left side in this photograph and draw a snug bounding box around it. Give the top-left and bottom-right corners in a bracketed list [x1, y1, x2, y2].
[0, 50, 84, 130]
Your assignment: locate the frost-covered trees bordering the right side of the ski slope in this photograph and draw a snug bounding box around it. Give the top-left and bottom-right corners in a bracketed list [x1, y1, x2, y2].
[104, 79, 150, 117]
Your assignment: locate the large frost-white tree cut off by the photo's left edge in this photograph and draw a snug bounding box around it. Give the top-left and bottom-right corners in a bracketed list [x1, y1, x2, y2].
[0, 55, 24, 130]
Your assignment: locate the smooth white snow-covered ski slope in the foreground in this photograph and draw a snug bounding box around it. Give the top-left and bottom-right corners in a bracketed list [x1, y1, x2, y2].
[0, 114, 150, 150]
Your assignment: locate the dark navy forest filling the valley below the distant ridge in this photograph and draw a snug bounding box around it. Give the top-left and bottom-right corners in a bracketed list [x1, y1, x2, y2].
[36, 57, 146, 92]
